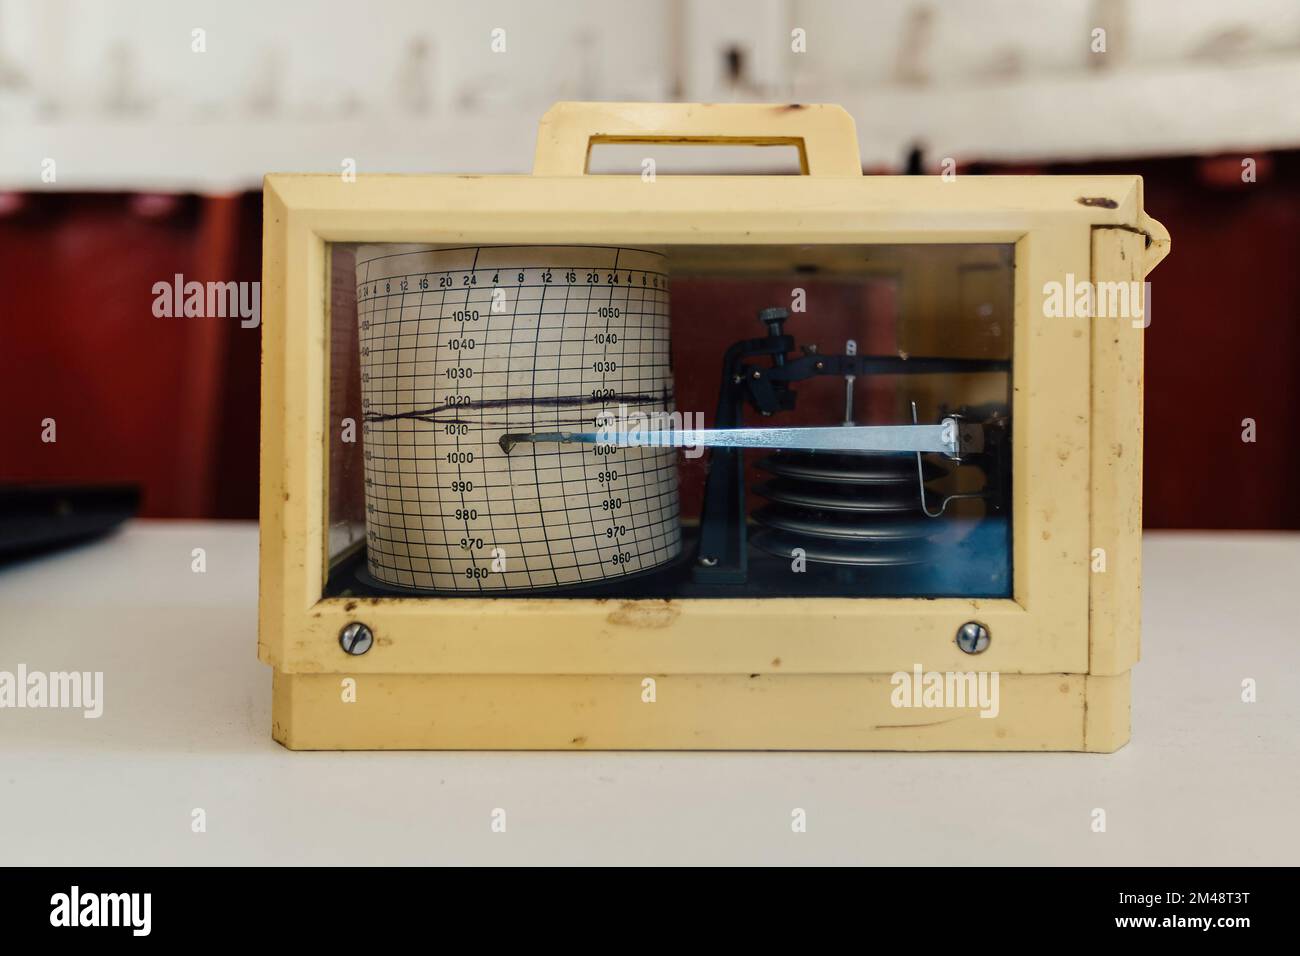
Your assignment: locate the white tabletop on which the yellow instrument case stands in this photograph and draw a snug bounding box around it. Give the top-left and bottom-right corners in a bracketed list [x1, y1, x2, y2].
[0, 523, 1300, 865]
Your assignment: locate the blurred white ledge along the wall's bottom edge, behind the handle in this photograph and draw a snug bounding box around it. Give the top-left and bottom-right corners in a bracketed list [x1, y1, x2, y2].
[0, 56, 1300, 193]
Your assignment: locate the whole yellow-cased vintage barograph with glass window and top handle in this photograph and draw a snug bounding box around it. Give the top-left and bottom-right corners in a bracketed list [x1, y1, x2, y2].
[259, 103, 1169, 750]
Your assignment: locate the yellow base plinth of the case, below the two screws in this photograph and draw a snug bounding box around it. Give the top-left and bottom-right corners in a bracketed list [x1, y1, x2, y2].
[272, 670, 1130, 753]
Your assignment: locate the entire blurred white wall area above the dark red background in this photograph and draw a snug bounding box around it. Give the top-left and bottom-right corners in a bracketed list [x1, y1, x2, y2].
[0, 0, 1300, 189]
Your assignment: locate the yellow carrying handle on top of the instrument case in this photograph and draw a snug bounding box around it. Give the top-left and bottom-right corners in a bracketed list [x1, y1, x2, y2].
[533, 103, 862, 177]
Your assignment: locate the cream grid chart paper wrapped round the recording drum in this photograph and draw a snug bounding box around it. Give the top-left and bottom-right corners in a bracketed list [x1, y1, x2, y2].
[356, 245, 681, 592]
